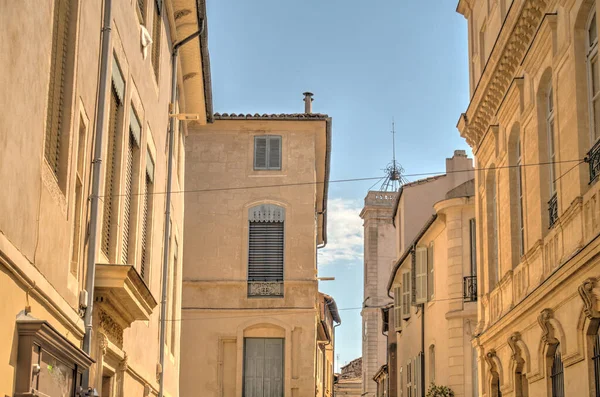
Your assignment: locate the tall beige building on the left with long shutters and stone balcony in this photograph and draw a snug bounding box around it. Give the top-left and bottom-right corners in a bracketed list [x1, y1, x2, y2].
[0, 0, 212, 396]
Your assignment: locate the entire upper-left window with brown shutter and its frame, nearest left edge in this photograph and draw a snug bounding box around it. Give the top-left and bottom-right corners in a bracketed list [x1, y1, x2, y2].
[44, 0, 77, 188]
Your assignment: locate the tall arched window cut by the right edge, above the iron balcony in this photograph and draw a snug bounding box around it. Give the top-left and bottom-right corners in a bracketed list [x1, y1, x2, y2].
[586, 5, 600, 144]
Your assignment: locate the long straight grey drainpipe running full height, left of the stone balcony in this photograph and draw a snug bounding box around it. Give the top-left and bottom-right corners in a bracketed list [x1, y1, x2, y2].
[82, 0, 112, 393]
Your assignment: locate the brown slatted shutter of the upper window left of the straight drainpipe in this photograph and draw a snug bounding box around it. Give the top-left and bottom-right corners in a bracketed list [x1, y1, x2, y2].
[44, 0, 72, 177]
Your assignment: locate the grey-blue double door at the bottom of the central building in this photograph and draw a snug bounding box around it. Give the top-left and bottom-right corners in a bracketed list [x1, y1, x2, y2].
[244, 338, 284, 397]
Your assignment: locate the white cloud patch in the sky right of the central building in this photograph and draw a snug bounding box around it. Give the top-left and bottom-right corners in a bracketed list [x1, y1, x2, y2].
[318, 198, 364, 265]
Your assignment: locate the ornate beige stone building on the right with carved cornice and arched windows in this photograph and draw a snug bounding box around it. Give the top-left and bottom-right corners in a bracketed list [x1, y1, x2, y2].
[458, 0, 600, 396]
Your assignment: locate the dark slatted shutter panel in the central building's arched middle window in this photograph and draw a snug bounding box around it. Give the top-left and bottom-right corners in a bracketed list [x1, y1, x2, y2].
[248, 222, 284, 281]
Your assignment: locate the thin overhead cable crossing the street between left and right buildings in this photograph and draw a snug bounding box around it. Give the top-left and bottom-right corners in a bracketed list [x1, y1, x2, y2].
[99, 159, 586, 198]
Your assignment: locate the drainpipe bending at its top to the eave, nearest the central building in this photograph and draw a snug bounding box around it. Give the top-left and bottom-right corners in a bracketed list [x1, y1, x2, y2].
[158, 26, 204, 397]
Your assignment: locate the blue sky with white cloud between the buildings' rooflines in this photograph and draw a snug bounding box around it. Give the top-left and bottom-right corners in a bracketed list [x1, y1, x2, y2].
[207, 0, 469, 367]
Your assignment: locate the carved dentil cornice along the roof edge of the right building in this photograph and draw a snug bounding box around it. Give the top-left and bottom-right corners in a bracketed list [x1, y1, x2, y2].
[459, 0, 548, 151]
